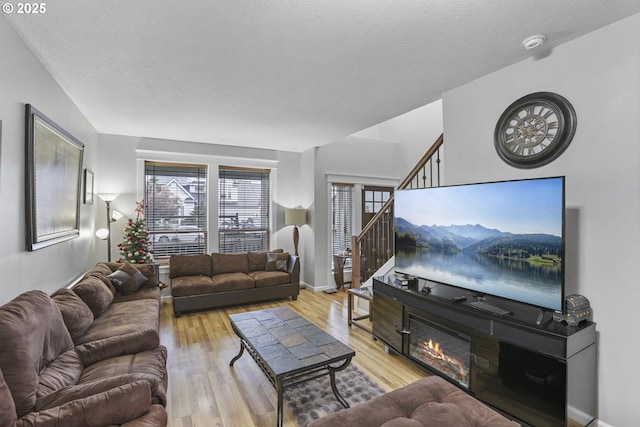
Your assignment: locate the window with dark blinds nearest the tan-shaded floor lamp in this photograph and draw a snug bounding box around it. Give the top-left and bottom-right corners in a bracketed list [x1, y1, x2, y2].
[218, 166, 271, 253]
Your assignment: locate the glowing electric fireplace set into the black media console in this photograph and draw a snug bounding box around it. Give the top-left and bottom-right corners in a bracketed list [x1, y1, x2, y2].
[408, 314, 471, 389]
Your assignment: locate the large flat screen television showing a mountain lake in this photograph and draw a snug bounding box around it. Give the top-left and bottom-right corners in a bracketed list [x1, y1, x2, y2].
[394, 177, 565, 312]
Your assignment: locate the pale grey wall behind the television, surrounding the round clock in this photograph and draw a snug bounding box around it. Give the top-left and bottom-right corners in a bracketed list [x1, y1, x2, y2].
[443, 15, 640, 427]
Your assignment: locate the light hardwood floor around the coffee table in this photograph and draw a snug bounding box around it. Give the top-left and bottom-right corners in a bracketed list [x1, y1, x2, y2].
[160, 289, 429, 427]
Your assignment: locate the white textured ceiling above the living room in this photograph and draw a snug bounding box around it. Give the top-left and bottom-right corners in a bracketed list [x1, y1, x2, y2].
[4, 0, 640, 152]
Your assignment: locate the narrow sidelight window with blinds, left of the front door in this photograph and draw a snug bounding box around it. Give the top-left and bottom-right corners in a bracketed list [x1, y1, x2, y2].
[331, 184, 353, 259]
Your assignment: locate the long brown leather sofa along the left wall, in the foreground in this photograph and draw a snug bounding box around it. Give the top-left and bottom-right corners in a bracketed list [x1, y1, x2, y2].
[0, 263, 168, 427]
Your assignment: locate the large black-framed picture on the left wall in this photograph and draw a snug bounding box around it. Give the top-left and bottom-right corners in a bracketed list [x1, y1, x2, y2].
[25, 104, 84, 251]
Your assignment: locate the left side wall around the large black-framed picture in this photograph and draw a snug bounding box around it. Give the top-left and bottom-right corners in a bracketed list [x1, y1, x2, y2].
[0, 18, 102, 304]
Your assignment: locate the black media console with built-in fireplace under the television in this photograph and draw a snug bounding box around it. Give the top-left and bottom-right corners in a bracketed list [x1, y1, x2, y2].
[372, 275, 596, 426]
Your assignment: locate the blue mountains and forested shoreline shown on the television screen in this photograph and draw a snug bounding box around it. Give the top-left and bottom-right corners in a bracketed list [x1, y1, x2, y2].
[395, 218, 562, 262]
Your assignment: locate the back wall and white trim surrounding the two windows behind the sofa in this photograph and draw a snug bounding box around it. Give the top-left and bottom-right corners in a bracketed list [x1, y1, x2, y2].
[96, 135, 310, 259]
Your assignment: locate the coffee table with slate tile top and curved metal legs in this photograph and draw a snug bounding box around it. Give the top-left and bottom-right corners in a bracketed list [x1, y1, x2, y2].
[229, 307, 356, 427]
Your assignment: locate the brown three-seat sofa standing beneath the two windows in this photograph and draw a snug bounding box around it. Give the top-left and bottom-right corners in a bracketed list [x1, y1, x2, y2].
[169, 250, 300, 317]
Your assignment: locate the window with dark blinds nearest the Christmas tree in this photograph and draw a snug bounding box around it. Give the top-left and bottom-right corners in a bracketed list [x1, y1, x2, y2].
[144, 162, 207, 259]
